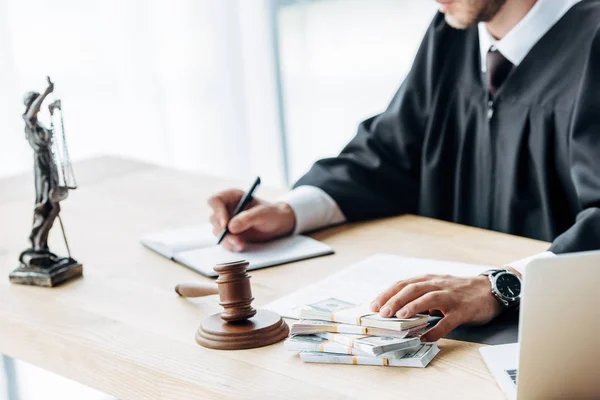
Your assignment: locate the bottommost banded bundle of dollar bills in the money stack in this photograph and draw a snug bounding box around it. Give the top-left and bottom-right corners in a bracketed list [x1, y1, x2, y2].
[300, 343, 440, 368]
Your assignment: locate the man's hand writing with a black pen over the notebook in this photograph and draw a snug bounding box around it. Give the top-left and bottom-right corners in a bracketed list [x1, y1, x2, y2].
[208, 189, 296, 252]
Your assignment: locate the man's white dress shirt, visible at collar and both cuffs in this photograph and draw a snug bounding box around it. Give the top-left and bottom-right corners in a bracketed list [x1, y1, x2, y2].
[280, 0, 581, 272]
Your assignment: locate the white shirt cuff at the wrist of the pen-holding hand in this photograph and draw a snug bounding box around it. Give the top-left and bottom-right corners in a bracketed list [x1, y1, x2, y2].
[279, 186, 346, 234]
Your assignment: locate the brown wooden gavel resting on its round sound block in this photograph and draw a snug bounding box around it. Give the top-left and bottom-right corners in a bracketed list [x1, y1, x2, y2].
[175, 261, 289, 350]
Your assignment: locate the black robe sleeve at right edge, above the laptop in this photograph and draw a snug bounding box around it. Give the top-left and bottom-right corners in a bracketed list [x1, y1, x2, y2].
[550, 28, 600, 253]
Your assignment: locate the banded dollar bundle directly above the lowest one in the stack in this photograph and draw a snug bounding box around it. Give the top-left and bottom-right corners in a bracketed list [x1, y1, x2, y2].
[316, 332, 421, 356]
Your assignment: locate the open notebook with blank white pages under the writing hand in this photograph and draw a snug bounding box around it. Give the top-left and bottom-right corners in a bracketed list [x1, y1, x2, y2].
[140, 224, 333, 277]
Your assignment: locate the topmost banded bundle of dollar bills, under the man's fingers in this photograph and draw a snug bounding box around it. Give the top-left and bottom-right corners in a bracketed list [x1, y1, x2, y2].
[300, 298, 427, 331]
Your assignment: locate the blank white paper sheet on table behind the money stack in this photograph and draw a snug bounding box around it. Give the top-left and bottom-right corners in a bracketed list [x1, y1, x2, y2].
[263, 254, 490, 319]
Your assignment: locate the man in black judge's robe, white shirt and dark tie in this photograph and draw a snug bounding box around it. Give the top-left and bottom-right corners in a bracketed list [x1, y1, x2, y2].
[209, 0, 600, 341]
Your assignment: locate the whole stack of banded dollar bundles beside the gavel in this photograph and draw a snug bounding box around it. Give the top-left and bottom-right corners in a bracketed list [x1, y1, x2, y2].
[284, 298, 439, 368]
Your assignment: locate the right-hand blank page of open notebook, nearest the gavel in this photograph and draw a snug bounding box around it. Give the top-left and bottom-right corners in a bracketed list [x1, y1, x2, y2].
[174, 235, 333, 277]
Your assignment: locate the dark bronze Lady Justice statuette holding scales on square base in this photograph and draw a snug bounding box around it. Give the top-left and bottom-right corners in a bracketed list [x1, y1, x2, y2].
[10, 77, 83, 287]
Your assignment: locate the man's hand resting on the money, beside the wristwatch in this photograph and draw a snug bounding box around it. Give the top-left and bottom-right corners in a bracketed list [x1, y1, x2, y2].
[371, 275, 502, 342]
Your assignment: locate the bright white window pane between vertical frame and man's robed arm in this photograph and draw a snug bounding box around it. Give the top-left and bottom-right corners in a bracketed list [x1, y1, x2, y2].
[278, 0, 437, 181]
